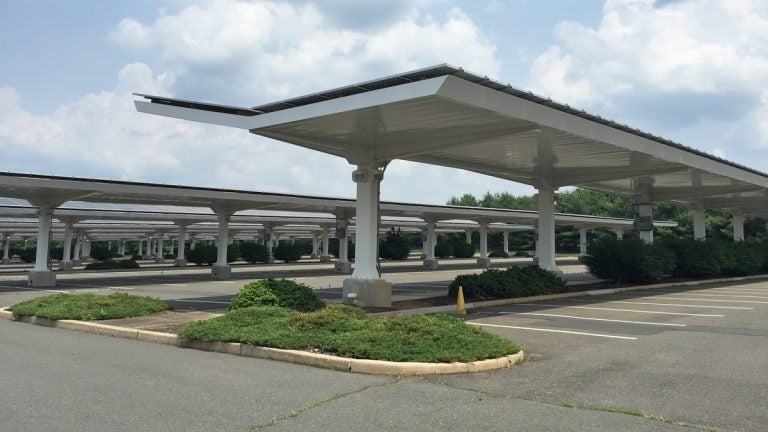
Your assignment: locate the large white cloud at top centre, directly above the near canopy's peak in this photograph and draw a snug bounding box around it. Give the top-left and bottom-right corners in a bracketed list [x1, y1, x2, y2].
[111, 0, 500, 105]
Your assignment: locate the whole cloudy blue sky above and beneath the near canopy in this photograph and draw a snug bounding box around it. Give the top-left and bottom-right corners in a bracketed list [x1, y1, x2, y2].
[0, 0, 768, 204]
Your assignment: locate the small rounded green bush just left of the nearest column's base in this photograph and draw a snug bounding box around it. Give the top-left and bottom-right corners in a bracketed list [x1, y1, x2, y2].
[229, 278, 325, 312]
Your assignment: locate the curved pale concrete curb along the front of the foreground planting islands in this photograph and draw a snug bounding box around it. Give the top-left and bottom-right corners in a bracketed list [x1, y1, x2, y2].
[0, 308, 525, 376]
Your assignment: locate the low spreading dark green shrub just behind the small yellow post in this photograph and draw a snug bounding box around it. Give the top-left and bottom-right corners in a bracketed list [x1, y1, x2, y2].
[448, 266, 566, 300]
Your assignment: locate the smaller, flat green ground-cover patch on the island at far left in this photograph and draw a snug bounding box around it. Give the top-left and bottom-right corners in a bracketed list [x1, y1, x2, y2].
[9, 293, 168, 321]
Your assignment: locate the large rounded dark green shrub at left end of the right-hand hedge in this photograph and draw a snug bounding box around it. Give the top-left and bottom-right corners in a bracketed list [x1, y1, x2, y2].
[584, 237, 675, 284]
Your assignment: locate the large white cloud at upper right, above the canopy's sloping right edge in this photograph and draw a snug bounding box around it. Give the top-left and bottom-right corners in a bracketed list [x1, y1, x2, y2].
[530, 0, 768, 160]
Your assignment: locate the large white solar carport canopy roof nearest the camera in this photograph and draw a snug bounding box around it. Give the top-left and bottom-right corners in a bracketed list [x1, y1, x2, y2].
[136, 65, 768, 214]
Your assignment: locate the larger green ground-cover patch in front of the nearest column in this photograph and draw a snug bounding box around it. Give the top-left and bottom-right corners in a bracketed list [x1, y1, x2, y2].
[179, 305, 520, 363]
